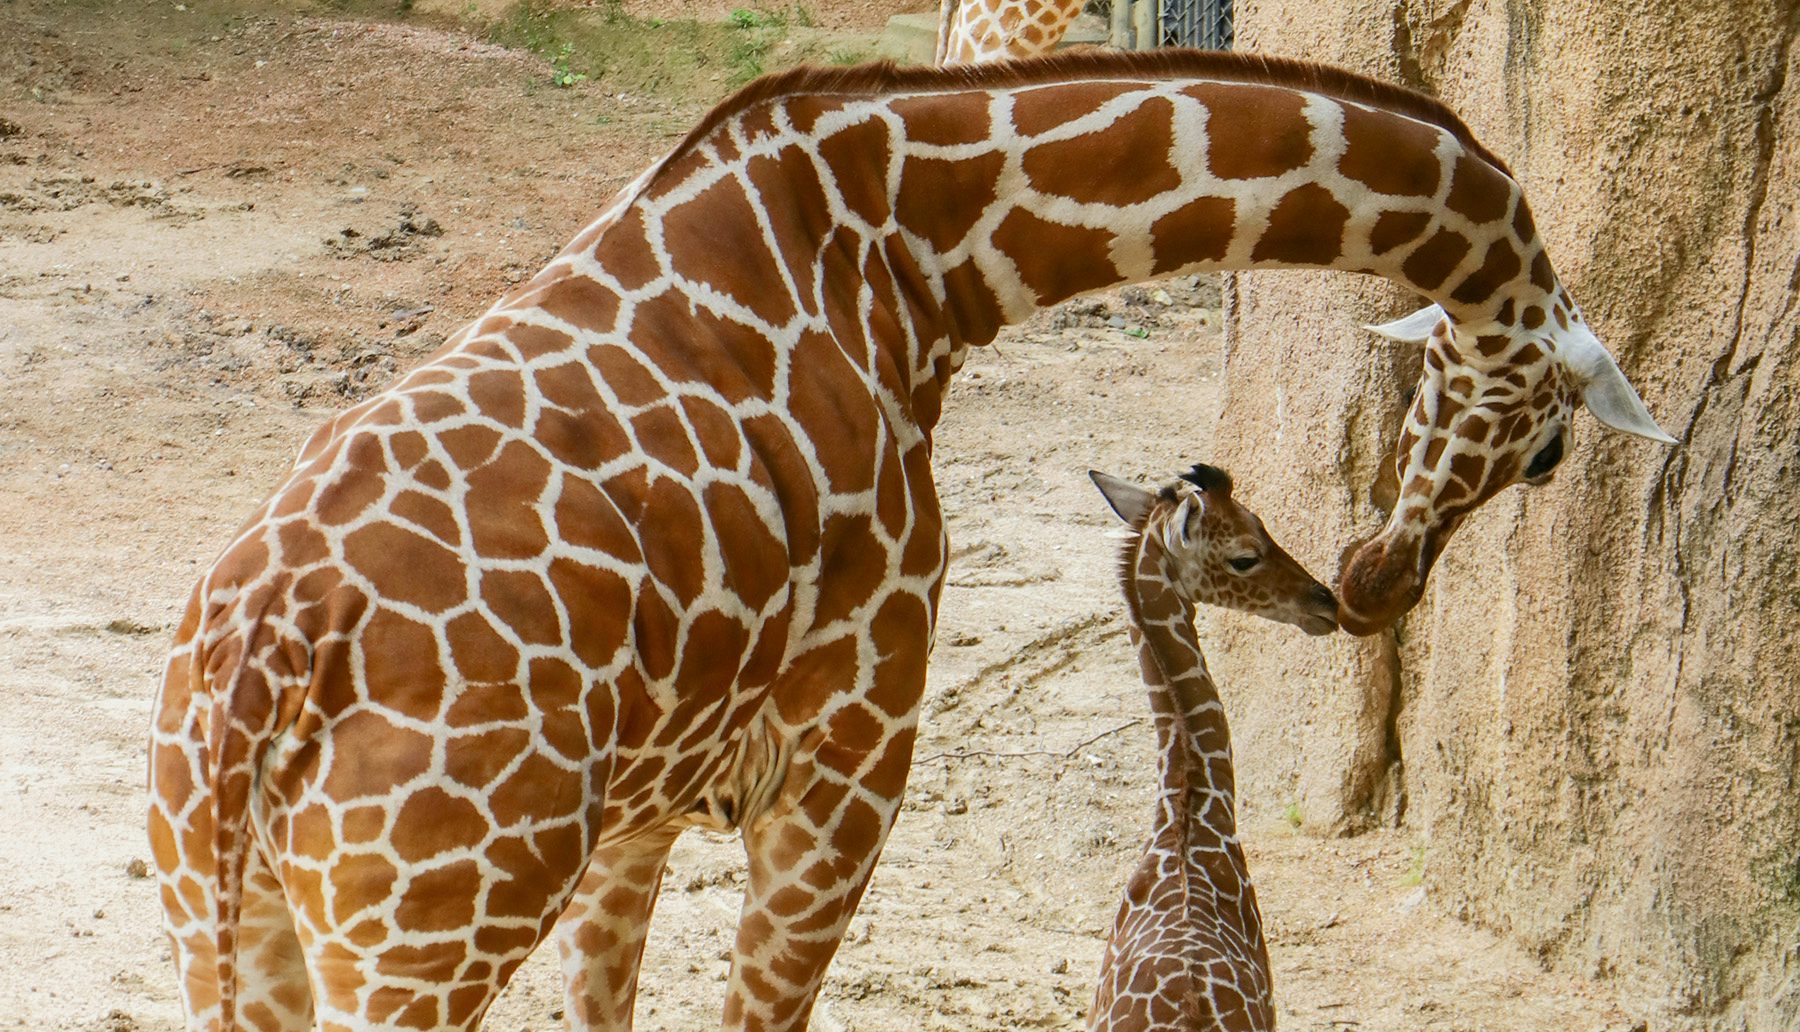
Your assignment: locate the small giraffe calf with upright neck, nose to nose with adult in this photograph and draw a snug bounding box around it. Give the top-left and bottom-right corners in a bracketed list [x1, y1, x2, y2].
[1087, 465, 1337, 1032]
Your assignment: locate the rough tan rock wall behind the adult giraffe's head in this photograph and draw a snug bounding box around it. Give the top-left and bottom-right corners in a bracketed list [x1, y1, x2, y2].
[1215, 0, 1800, 1028]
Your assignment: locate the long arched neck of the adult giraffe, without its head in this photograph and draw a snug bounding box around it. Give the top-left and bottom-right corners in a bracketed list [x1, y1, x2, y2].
[657, 54, 1557, 329]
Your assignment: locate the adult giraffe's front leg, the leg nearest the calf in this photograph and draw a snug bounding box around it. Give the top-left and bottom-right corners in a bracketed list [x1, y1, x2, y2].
[725, 600, 931, 1032]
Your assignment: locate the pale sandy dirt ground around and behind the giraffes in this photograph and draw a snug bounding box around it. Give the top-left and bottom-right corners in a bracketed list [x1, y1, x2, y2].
[0, 0, 1640, 1032]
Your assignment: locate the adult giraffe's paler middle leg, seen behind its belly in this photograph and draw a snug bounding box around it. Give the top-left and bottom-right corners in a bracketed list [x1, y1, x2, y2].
[556, 827, 680, 1032]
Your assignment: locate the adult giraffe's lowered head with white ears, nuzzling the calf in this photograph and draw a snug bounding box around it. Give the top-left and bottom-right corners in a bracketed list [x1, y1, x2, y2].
[1337, 302, 1674, 634]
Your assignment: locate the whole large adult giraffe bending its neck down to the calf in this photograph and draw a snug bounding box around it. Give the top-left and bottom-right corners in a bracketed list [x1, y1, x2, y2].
[149, 52, 1660, 1028]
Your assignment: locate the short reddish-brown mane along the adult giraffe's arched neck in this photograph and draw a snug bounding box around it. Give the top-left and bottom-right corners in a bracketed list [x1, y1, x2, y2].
[662, 49, 1512, 177]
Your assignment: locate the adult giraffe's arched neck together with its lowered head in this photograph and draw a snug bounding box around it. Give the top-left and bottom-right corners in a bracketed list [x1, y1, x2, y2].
[477, 52, 1669, 634]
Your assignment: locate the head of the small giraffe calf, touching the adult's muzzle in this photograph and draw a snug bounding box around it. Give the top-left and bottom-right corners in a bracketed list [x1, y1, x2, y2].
[1087, 465, 1337, 634]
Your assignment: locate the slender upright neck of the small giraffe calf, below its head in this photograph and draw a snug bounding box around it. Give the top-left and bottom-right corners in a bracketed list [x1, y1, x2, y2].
[1121, 533, 1237, 852]
